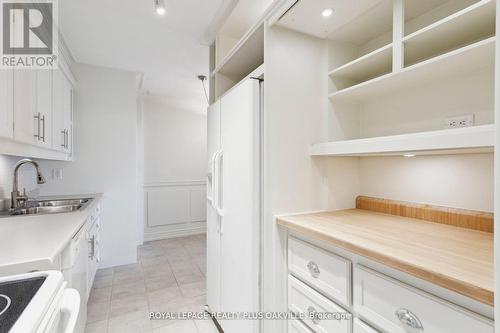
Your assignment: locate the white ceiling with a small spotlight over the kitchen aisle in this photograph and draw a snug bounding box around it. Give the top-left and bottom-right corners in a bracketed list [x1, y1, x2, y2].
[59, 0, 222, 108]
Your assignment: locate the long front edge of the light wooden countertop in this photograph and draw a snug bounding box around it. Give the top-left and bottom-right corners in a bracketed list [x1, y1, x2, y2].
[276, 217, 494, 306]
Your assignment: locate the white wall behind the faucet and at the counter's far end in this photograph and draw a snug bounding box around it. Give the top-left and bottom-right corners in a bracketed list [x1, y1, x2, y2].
[0, 64, 138, 268]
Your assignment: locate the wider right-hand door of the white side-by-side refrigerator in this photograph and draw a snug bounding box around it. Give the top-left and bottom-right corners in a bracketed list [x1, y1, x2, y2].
[219, 79, 260, 333]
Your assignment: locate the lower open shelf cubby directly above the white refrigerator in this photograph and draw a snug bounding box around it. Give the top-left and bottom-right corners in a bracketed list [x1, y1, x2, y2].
[211, 23, 264, 79]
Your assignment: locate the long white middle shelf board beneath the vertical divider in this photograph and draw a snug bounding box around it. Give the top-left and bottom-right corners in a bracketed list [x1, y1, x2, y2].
[329, 37, 495, 103]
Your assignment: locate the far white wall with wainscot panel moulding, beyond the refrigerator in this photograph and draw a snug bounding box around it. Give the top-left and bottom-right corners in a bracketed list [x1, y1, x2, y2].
[143, 94, 207, 240]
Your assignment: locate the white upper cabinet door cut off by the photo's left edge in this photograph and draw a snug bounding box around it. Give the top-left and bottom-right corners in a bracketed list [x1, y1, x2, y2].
[0, 69, 14, 138]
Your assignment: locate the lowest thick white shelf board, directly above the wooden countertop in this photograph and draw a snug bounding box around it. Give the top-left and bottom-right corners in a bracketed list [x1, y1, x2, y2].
[310, 125, 495, 156]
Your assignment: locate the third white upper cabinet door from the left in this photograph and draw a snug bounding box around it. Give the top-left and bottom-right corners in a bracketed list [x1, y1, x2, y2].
[36, 70, 52, 148]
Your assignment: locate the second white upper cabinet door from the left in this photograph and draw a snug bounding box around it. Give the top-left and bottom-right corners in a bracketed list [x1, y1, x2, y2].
[14, 69, 37, 144]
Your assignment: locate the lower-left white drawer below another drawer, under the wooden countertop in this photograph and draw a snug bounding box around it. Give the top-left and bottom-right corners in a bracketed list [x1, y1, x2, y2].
[288, 275, 352, 333]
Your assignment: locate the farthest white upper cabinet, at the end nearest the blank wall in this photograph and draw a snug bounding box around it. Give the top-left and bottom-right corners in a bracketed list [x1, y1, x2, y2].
[52, 70, 73, 152]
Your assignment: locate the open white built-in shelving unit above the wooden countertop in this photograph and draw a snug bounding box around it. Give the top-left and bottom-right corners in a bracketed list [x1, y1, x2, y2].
[276, 0, 496, 156]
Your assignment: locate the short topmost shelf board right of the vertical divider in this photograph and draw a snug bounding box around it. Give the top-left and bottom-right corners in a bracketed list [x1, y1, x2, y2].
[403, 0, 495, 64]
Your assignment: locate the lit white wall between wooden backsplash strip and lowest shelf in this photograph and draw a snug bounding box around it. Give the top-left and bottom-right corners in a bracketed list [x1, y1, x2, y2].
[360, 154, 494, 212]
